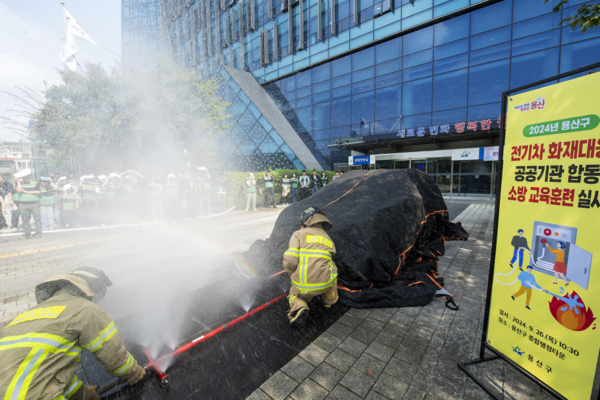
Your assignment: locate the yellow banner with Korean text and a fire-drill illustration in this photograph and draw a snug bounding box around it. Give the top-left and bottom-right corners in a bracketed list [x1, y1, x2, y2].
[487, 73, 600, 399]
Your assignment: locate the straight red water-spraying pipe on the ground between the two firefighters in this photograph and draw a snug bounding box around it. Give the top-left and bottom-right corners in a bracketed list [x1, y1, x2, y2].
[96, 292, 287, 395]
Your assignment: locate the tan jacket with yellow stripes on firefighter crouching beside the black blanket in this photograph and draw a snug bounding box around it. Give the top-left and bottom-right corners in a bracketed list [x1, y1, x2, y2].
[283, 214, 337, 295]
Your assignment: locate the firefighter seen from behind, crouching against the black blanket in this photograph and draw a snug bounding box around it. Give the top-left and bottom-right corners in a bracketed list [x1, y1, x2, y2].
[283, 207, 338, 327]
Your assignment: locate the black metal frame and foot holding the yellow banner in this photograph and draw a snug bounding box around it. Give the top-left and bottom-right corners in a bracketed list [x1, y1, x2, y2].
[457, 63, 600, 400]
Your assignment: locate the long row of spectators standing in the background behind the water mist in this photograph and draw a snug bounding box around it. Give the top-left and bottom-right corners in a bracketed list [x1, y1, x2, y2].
[0, 167, 343, 238]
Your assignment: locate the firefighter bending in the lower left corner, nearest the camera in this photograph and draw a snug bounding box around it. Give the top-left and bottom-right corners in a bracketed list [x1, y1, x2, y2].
[0, 267, 146, 400]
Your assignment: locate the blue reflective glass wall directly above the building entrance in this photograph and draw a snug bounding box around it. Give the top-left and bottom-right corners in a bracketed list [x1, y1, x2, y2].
[265, 0, 600, 166]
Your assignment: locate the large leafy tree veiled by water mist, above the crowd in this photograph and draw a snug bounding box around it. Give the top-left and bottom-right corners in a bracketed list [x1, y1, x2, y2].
[4, 59, 227, 174]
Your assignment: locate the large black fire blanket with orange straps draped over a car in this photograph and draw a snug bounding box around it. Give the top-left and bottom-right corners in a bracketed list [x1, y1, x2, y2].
[244, 170, 468, 308]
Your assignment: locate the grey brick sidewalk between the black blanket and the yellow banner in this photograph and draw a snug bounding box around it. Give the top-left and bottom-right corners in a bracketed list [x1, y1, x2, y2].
[247, 204, 576, 400]
